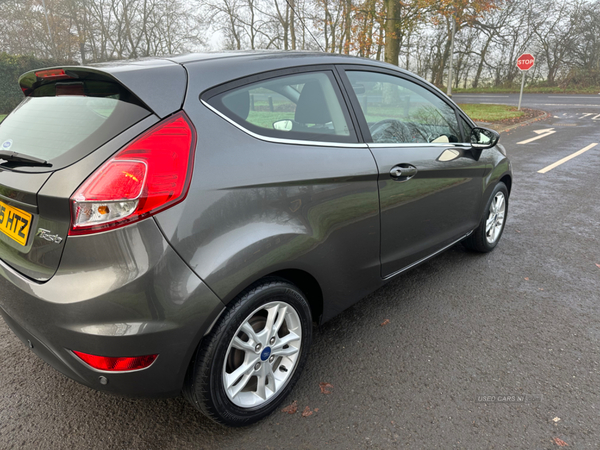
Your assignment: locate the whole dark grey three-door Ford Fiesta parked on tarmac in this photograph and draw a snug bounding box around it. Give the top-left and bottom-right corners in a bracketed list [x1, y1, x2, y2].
[0, 52, 512, 426]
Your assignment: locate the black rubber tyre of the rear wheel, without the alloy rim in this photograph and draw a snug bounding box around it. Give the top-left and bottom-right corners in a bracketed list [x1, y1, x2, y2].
[186, 280, 312, 426]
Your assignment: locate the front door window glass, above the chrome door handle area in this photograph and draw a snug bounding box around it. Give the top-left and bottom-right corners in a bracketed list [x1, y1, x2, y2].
[347, 71, 461, 144]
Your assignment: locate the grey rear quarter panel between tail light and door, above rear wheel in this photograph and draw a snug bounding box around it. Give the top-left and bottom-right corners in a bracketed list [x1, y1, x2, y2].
[156, 61, 381, 320]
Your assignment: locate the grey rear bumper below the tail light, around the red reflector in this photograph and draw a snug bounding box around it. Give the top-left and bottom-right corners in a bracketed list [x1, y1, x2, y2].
[0, 219, 224, 396]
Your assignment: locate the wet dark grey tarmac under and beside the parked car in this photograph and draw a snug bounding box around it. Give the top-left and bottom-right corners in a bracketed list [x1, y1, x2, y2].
[0, 95, 600, 449]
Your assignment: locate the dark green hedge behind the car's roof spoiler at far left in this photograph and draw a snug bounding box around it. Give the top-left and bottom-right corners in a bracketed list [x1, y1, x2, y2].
[0, 53, 62, 114]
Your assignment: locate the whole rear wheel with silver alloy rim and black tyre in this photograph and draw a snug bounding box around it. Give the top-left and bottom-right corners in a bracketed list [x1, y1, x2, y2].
[183, 278, 312, 426]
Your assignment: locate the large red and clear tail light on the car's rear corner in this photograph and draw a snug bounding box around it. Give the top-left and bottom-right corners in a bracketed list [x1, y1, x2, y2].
[69, 112, 196, 235]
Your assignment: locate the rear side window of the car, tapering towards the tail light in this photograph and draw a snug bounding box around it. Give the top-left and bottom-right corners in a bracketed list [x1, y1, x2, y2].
[208, 72, 356, 142]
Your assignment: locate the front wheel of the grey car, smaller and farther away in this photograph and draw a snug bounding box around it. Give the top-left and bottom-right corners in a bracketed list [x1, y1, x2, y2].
[462, 182, 508, 253]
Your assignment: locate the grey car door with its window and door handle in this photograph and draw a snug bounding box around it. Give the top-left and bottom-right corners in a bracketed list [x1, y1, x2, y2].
[344, 66, 485, 278]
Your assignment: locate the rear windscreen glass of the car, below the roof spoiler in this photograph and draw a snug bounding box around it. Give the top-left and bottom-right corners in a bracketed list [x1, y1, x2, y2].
[0, 81, 150, 170]
